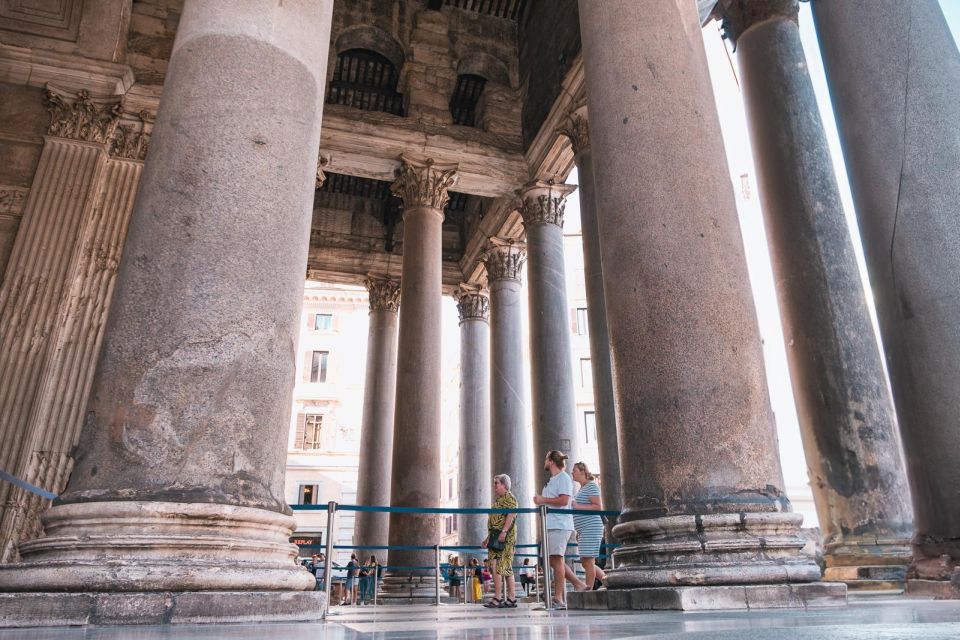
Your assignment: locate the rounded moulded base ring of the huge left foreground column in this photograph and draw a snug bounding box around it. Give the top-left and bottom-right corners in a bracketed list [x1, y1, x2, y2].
[0, 501, 315, 592]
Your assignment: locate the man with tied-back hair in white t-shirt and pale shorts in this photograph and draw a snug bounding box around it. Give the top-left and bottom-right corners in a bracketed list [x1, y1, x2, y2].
[533, 451, 586, 609]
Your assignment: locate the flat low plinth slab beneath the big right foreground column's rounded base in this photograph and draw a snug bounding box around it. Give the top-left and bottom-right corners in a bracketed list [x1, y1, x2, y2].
[567, 582, 847, 611]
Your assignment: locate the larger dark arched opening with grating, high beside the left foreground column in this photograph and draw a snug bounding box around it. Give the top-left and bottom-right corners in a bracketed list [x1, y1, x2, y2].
[327, 49, 403, 116]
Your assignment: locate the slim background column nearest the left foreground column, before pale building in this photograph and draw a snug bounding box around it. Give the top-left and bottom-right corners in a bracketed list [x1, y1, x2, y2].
[353, 277, 400, 564]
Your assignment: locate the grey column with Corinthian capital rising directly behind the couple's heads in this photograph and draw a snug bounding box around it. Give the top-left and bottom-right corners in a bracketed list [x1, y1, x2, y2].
[519, 180, 580, 464]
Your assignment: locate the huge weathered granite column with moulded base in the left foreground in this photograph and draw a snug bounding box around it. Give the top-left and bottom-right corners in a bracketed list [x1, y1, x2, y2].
[0, 0, 332, 604]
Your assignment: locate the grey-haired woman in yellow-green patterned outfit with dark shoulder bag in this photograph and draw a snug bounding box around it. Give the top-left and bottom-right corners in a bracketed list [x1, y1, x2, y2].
[480, 473, 517, 609]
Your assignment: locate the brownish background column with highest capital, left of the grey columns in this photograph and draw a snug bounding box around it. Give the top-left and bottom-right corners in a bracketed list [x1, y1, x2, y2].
[387, 156, 457, 596]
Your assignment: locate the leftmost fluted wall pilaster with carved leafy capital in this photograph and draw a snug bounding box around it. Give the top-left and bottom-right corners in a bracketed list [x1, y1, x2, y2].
[0, 89, 120, 562]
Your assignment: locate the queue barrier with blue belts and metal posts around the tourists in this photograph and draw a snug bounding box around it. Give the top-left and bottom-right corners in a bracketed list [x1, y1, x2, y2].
[298, 501, 620, 619]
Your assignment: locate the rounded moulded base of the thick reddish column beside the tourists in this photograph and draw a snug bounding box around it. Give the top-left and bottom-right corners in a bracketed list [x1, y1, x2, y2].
[604, 512, 820, 589]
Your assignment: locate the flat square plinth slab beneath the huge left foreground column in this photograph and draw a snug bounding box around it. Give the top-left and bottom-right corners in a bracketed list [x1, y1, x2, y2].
[0, 591, 326, 627]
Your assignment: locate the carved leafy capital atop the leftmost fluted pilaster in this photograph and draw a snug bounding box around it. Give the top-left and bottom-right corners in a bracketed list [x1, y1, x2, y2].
[44, 85, 121, 143]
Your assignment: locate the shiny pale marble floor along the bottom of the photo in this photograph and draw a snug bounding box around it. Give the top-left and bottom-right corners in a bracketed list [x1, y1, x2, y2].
[0, 596, 960, 640]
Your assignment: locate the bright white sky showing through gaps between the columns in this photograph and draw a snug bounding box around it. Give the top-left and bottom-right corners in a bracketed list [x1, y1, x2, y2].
[442, 0, 960, 526]
